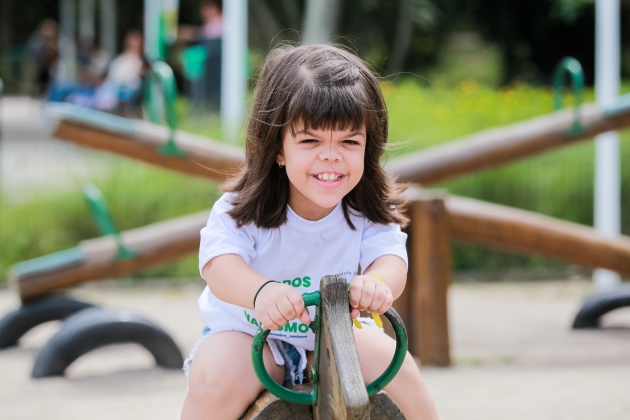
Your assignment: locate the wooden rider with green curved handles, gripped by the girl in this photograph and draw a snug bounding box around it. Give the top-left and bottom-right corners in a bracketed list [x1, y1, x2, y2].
[241, 275, 407, 420]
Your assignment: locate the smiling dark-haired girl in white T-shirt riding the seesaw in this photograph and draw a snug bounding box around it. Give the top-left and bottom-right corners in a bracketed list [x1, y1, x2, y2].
[182, 45, 437, 420]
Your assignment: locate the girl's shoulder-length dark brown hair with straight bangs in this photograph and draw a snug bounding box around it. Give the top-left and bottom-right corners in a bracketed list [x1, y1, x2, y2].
[223, 45, 408, 229]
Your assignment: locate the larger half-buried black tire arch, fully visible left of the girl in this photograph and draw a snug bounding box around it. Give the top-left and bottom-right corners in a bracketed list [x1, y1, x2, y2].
[31, 308, 184, 378]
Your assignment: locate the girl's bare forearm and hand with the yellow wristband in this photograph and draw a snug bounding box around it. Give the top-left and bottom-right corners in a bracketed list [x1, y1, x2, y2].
[350, 255, 407, 318]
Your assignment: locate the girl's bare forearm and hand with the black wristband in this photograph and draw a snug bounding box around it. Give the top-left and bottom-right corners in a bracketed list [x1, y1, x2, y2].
[202, 254, 311, 330]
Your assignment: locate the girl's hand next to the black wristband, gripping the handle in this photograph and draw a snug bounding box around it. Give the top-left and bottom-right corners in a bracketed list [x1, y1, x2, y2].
[254, 283, 311, 330]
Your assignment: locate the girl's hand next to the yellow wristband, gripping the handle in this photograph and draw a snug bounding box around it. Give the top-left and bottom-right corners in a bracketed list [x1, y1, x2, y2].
[350, 275, 394, 318]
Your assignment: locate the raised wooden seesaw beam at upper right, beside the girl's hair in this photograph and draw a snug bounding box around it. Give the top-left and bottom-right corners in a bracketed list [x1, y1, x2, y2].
[385, 96, 630, 185]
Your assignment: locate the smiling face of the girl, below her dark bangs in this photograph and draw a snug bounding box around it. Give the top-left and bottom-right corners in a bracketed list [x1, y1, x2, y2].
[276, 127, 366, 220]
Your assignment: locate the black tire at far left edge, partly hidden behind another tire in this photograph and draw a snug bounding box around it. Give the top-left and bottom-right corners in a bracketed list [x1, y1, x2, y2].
[0, 295, 94, 349]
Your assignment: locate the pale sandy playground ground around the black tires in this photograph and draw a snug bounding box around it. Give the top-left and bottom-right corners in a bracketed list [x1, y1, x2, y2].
[0, 280, 630, 420]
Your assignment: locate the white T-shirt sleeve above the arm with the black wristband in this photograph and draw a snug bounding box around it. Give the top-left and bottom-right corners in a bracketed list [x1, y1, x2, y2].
[199, 194, 256, 273]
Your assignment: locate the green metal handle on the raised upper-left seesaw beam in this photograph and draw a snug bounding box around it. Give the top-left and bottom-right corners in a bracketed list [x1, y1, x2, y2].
[146, 61, 185, 156]
